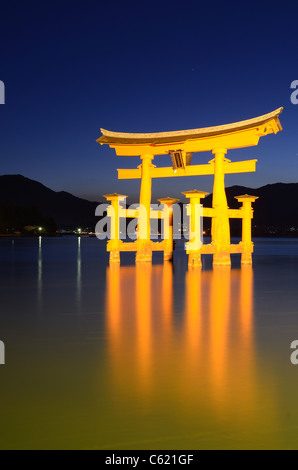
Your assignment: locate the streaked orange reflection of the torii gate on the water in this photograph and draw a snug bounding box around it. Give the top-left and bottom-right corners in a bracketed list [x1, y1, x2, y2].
[106, 263, 276, 446]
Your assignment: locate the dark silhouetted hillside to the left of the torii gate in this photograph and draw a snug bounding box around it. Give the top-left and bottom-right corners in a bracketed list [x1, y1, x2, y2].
[0, 175, 98, 228]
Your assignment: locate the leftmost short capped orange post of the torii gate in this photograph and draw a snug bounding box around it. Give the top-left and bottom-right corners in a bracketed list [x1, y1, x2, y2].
[104, 193, 127, 263]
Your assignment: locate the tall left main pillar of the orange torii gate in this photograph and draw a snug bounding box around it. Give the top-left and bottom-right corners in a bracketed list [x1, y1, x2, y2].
[136, 154, 154, 262]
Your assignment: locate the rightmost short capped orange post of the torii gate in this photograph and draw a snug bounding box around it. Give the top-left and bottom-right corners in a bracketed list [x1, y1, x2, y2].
[235, 194, 259, 264]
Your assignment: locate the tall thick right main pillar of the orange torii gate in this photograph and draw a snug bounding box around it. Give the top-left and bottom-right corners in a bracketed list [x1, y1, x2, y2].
[211, 148, 231, 266]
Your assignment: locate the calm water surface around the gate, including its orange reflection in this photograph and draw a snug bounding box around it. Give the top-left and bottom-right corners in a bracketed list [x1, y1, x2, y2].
[0, 238, 298, 450]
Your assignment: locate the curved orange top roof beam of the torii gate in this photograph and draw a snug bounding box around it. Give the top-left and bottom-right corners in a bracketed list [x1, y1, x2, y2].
[97, 108, 283, 156]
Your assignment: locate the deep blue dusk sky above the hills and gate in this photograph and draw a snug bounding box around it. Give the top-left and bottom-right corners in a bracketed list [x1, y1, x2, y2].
[0, 0, 298, 200]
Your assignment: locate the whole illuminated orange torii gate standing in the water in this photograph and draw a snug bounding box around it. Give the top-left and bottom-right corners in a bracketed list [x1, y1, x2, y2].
[97, 108, 282, 266]
